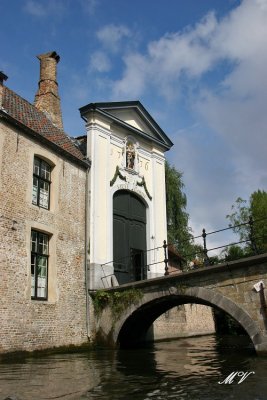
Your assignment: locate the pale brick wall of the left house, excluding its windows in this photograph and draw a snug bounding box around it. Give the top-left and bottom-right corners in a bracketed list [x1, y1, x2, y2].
[0, 121, 87, 353]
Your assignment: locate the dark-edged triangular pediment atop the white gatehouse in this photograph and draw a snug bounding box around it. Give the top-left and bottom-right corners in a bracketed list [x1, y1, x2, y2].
[80, 101, 173, 150]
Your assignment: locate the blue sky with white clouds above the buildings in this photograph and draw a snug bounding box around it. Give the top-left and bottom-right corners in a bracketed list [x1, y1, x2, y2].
[0, 0, 267, 255]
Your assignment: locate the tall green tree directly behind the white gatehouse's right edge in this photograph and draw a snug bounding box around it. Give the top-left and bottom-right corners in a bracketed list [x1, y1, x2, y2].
[165, 162, 194, 256]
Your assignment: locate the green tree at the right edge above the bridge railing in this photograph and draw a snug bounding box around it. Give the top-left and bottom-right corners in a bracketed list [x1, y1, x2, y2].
[226, 190, 267, 255]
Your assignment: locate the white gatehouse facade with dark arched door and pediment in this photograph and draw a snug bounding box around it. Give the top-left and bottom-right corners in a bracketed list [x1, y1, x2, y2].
[80, 101, 172, 289]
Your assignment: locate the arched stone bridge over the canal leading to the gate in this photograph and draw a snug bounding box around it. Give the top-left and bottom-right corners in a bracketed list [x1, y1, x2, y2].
[91, 253, 267, 354]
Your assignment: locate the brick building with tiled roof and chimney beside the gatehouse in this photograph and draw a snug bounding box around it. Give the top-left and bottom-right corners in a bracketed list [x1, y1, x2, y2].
[0, 52, 89, 353]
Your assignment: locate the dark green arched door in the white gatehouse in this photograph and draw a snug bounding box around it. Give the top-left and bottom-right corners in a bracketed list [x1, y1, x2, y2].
[113, 190, 147, 285]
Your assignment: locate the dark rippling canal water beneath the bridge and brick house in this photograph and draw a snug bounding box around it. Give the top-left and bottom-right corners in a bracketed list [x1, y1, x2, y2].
[0, 335, 267, 400]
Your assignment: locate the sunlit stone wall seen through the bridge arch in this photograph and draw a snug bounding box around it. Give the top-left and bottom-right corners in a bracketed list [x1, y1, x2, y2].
[149, 304, 215, 340]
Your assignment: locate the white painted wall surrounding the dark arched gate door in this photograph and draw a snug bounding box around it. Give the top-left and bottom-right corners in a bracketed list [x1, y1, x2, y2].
[86, 108, 170, 289]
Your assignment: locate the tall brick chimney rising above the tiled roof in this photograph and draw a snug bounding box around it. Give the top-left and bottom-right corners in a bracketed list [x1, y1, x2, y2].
[34, 51, 63, 129]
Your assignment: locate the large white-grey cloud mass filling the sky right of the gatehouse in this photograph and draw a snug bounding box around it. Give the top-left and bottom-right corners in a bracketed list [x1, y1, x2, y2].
[113, 0, 267, 220]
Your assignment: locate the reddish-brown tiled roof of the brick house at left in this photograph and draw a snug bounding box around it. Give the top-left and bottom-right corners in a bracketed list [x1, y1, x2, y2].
[2, 86, 87, 161]
